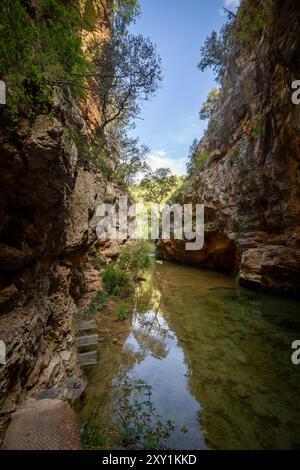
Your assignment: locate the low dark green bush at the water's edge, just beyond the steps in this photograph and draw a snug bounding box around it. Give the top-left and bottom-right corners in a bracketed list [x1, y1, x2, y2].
[102, 265, 133, 297]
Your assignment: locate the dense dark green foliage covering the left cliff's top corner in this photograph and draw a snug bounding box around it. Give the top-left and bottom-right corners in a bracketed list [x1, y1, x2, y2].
[0, 0, 90, 116]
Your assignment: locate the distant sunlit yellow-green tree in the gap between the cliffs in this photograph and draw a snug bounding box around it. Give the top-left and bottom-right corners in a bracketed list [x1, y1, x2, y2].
[140, 168, 177, 208]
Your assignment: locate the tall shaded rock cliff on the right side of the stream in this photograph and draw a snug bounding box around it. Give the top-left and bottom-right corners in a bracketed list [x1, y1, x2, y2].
[158, 0, 300, 294]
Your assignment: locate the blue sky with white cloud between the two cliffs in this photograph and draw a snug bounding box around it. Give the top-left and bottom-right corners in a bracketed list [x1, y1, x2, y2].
[130, 0, 238, 174]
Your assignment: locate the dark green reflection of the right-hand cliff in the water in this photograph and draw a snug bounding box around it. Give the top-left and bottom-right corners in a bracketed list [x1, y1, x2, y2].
[154, 264, 300, 449]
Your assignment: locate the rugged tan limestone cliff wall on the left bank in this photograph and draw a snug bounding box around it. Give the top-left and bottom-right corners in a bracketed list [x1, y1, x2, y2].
[0, 2, 121, 440]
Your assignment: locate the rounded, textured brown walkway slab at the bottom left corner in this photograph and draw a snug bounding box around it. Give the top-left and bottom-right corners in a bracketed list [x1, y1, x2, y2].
[3, 399, 81, 450]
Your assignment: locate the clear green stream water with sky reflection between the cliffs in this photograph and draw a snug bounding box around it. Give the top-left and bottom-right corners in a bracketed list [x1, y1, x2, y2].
[79, 263, 300, 449]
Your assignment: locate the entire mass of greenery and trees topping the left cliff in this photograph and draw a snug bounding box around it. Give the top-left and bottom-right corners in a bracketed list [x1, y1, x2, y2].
[0, 0, 161, 191]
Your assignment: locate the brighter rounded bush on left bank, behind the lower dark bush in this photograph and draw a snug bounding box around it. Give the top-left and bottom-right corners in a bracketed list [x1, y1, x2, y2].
[118, 242, 150, 280]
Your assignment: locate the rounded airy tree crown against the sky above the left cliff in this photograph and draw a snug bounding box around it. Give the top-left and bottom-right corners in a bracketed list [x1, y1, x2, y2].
[98, 34, 161, 130]
